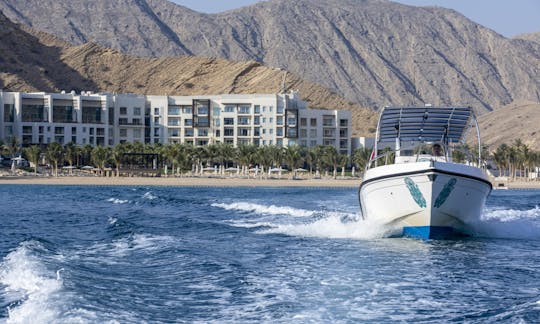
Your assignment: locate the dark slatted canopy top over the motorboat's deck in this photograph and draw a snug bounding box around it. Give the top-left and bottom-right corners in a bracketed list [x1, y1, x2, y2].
[377, 106, 476, 143]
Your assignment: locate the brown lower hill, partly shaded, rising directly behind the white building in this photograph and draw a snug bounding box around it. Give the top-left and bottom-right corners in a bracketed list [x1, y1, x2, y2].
[0, 13, 376, 136]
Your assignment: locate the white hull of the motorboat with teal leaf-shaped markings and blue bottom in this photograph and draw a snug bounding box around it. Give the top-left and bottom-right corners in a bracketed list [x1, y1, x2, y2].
[359, 161, 492, 239]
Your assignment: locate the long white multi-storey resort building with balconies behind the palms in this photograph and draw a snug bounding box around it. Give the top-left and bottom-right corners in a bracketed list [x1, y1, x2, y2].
[0, 91, 352, 155]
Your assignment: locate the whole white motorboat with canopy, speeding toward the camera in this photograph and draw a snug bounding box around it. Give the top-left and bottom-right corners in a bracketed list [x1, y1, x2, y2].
[359, 105, 492, 239]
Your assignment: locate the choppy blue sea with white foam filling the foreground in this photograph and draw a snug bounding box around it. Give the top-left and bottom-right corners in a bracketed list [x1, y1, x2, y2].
[0, 185, 540, 323]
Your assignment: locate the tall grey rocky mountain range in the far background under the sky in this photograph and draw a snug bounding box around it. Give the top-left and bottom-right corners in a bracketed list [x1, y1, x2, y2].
[0, 0, 540, 113]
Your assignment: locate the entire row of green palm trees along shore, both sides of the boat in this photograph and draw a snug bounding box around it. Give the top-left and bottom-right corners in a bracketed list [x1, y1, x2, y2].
[0, 138, 540, 180]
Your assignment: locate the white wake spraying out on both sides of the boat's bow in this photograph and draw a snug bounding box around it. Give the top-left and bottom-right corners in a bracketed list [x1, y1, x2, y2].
[212, 202, 540, 240]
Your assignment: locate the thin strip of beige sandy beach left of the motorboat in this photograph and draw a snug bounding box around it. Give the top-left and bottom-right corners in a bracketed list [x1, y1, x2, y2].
[0, 176, 360, 188]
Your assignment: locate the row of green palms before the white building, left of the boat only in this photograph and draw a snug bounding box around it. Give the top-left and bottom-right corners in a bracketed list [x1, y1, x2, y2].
[2, 141, 371, 177]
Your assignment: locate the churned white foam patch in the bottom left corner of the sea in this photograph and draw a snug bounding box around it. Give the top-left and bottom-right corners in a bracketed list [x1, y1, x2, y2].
[0, 242, 62, 323]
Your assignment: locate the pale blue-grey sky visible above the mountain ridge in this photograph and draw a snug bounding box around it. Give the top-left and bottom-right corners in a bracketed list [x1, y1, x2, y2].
[171, 0, 540, 37]
